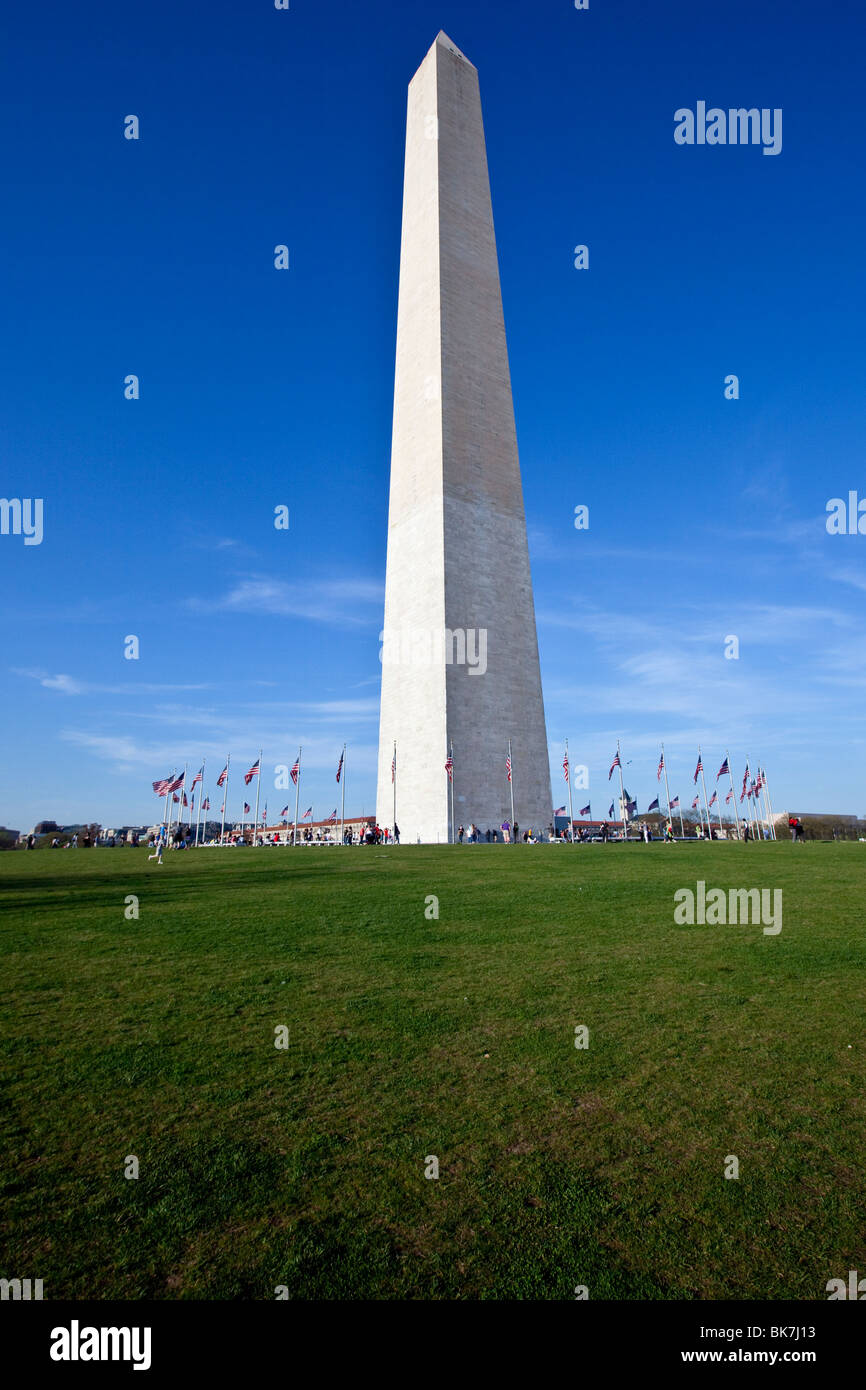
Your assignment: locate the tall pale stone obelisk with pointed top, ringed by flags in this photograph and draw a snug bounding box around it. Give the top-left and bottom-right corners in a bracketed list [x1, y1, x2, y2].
[377, 33, 552, 844]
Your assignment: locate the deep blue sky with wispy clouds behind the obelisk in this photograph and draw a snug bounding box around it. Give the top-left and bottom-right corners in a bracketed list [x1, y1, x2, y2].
[0, 0, 866, 828]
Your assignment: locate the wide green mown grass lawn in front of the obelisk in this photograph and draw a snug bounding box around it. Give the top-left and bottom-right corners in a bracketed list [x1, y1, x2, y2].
[0, 844, 866, 1298]
